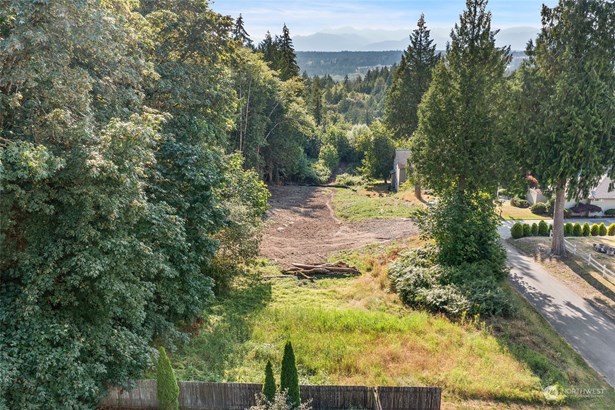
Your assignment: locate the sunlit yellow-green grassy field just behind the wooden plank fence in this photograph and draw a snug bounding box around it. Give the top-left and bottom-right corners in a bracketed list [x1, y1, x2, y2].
[165, 239, 615, 409]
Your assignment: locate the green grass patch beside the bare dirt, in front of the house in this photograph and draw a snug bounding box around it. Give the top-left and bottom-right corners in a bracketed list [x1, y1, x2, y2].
[333, 184, 421, 222]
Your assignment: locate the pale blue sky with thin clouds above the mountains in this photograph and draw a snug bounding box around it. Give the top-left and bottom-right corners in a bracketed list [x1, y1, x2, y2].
[212, 0, 557, 39]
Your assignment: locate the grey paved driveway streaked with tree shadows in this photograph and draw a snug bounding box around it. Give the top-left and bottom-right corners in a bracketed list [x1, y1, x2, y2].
[501, 237, 615, 387]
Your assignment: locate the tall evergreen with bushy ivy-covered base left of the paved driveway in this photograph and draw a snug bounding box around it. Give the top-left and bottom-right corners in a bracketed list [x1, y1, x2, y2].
[411, 0, 510, 264]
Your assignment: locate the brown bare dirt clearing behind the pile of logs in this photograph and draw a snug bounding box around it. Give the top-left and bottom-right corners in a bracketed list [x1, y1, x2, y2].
[261, 186, 418, 267]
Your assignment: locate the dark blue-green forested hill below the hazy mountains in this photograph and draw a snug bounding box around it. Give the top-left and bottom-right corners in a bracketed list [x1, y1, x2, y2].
[297, 50, 526, 81]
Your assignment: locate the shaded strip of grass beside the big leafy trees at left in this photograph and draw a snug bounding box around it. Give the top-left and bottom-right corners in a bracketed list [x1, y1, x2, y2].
[173, 278, 272, 382]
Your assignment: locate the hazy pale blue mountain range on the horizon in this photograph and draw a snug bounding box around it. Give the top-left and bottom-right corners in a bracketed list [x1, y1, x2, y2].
[293, 27, 539, 51]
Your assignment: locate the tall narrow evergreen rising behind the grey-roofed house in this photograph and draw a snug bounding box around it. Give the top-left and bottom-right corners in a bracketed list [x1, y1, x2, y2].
[385, 14, 438, 200]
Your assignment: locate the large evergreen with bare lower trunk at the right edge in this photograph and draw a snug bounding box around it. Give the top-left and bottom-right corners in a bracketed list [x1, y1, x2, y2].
[514, 0, 615, 256]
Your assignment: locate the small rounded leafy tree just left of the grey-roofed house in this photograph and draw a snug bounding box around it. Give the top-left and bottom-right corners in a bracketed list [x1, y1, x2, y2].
[362, 122, 395, 183]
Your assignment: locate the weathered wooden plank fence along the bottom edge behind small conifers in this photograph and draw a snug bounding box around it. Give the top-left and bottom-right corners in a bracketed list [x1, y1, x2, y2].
[100, 380, 442, 410]
